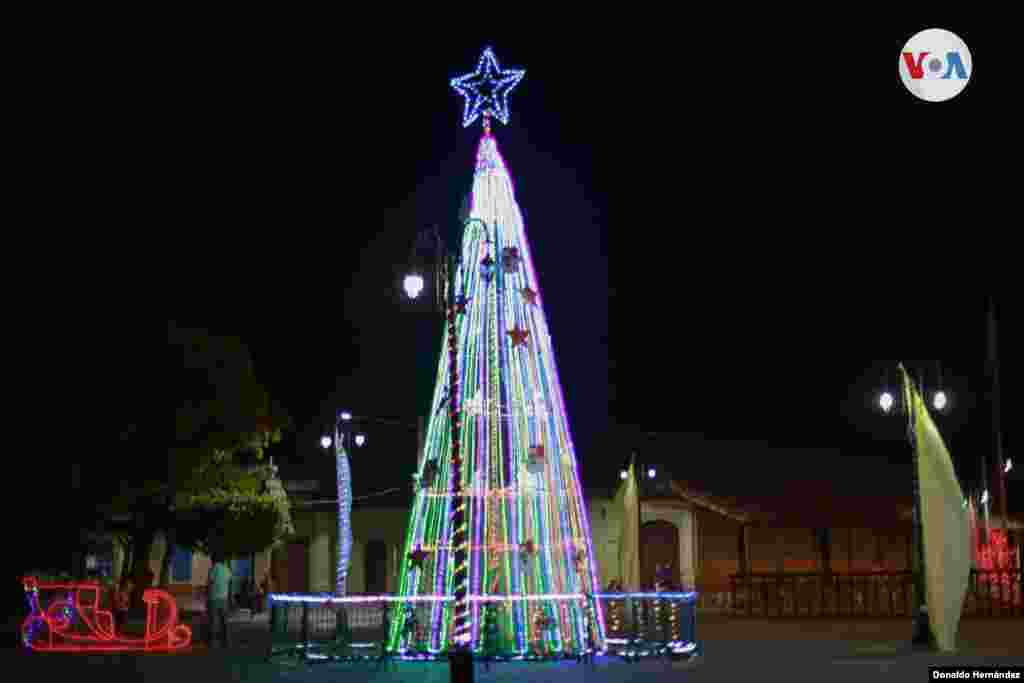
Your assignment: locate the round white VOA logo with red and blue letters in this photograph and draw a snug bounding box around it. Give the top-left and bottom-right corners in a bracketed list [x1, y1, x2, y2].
[899, 29, 973, 102]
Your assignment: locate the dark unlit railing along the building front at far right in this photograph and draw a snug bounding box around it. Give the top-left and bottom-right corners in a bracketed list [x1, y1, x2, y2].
[722, 569, 1024, 617]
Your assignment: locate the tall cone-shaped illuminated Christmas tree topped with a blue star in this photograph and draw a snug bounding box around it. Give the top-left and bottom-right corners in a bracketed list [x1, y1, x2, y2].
[388, 48, 604, 655]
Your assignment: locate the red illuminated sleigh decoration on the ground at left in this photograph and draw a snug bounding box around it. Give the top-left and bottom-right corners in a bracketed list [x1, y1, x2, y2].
[22, 577, 191, 652]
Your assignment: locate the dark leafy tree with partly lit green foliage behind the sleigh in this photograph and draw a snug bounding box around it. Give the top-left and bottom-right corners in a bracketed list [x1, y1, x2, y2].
[95, 324, 291, 586]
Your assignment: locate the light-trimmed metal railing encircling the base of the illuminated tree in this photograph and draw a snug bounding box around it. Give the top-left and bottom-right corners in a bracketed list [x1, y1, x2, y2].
[267, 593, 699, 660]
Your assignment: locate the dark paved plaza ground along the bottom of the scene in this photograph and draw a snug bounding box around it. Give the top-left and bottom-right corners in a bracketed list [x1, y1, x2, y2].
[4, 616, 1024, 683]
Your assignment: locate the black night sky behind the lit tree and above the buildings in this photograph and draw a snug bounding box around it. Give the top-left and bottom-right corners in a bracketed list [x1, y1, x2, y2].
[8, 25, 1024, 610]
